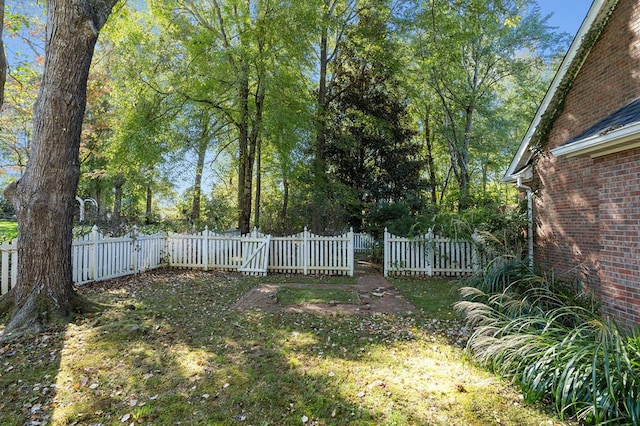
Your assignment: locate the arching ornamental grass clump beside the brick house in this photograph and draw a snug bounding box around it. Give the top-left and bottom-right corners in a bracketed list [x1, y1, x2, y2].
[455, 261, 640, 425]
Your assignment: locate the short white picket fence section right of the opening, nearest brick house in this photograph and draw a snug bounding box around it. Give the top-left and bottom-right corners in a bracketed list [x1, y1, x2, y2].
[384, 229, 487, 276]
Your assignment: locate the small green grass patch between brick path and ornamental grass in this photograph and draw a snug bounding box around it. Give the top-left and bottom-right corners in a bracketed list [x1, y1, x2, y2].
[389, 277, 459, 320]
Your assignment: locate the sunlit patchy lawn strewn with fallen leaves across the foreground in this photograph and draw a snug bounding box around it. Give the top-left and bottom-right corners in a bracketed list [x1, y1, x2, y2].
[0, 271, 563, 425]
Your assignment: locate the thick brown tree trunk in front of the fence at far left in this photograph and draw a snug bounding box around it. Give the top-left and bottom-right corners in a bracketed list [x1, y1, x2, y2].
[0, 0, 116, 338]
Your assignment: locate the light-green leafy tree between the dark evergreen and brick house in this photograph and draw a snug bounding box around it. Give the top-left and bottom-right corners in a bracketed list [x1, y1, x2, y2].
[414, 0, 558, 209]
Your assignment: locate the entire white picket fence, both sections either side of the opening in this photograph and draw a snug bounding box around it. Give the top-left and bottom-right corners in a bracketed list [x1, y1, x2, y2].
[0, 227, 486, 294]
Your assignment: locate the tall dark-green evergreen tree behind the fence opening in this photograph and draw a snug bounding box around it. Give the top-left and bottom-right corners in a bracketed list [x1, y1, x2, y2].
[327, 1, 423, 229]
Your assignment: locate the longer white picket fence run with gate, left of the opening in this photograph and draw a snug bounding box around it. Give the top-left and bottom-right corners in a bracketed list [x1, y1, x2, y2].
[0, 227, 354, 294]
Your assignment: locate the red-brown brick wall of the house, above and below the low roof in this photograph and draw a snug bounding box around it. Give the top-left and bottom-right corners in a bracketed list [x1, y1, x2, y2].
[533, 0, 640, 323]
